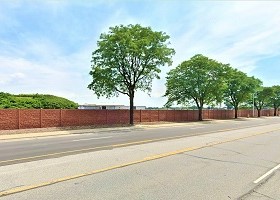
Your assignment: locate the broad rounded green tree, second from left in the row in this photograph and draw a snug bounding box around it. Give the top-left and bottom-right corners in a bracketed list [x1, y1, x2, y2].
[164, 54, 226, 121]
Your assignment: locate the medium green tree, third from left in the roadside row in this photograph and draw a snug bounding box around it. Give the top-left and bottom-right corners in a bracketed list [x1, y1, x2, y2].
[224, 67, 261, 118]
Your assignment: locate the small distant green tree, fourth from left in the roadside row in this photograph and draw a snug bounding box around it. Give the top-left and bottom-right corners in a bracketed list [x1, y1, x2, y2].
[253, 87, 273, 117]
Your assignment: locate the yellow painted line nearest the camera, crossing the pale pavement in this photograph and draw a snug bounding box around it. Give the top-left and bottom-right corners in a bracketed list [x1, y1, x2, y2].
[0, 128, 280, 197]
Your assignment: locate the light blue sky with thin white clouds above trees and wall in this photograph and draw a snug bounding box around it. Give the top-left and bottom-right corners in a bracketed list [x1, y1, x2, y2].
[0, 0, 280, 106]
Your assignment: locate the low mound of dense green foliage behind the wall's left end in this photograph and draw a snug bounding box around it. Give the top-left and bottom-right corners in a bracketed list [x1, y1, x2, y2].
[0, 92, 78, 109]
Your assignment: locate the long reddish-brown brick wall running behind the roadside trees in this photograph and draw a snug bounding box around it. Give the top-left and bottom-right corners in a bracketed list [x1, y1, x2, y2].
[0, 109, 273, 130]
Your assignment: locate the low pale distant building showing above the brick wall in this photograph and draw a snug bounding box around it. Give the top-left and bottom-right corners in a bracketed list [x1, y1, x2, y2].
[78, 104, 146, 110]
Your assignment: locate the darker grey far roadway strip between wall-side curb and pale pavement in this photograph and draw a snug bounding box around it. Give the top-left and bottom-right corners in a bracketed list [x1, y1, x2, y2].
[0, 117, 280, 166]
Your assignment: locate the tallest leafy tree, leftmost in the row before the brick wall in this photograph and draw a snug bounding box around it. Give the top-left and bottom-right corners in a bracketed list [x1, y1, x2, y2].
[88, 24, 175, 125]
